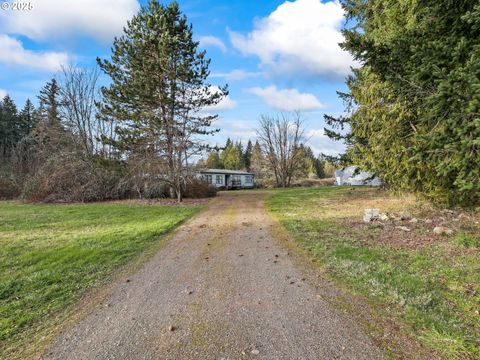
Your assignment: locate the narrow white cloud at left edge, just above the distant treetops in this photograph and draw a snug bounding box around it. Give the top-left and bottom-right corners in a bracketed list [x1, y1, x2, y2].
[0, 34, 68, 71]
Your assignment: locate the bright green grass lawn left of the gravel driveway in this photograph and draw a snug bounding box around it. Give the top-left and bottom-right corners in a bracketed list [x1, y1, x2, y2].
[0, 202, 200, 358]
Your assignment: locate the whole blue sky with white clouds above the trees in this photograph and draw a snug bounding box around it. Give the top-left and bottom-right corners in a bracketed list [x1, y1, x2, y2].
[0, 0, 355, 154]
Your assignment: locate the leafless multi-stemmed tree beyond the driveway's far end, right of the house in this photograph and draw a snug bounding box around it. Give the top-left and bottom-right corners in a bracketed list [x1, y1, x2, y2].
[257, 112, 304, 187]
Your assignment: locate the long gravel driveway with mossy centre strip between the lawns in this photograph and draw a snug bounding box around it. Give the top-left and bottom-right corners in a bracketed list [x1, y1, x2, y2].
[44, 191, 383, 359]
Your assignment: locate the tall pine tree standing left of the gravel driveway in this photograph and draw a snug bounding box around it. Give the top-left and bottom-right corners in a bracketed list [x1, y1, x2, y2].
[97, 0, 228, 201]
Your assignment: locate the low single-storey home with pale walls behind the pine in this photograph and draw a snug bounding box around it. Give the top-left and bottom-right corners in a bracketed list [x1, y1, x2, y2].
[199, 169, 255, 189]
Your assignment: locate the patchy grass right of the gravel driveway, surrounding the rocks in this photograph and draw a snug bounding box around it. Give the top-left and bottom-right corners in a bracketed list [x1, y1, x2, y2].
[267, 187, 480, 359]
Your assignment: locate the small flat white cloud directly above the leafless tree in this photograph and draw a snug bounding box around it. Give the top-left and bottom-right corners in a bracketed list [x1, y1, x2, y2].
[246, 86, 323, 111]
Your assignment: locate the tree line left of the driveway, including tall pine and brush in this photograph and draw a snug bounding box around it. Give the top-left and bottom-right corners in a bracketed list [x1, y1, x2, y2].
[0, 0, 223, 201]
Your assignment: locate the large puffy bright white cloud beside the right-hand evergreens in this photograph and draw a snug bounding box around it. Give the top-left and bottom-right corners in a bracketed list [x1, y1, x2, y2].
[229, 0, 355, 77]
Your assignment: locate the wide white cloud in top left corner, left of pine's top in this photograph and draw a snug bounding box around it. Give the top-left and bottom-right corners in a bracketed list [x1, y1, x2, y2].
[0, 0, 140, 41]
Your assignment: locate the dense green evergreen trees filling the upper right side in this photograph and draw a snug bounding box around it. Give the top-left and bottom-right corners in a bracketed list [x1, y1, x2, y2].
[326, 0, 480, 206]
